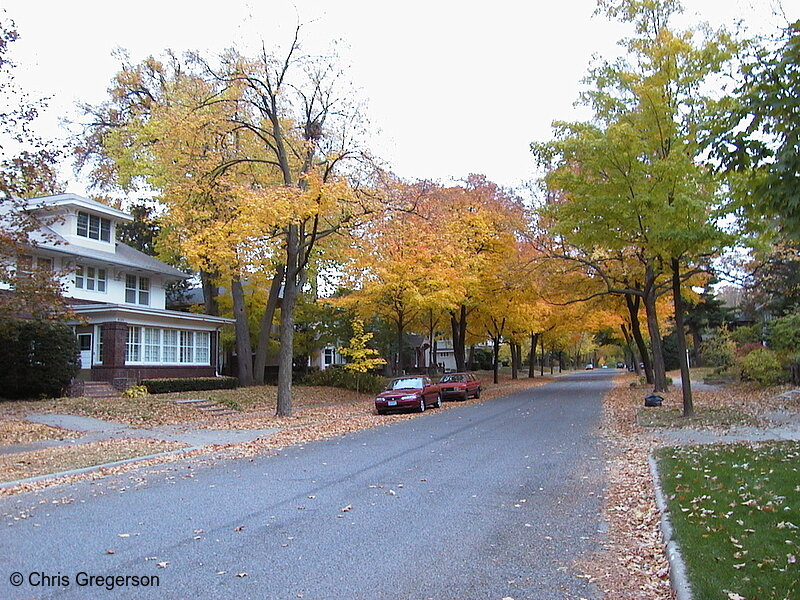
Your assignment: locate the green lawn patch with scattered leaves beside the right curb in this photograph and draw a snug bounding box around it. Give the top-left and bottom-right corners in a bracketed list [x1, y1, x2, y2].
[657, 441, 800, 600]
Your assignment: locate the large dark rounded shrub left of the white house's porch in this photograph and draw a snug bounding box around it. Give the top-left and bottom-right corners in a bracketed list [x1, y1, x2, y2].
[0, 319, 80, 398]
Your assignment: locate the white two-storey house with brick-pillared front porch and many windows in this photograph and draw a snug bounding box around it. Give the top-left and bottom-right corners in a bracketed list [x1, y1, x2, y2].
[4, 194, 231, 386]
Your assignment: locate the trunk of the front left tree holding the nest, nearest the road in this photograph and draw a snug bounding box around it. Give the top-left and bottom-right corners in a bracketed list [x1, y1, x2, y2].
[275, 224, 300, 417]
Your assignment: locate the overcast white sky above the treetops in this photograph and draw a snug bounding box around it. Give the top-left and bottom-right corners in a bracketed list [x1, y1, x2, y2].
[0, 0, 800, 194]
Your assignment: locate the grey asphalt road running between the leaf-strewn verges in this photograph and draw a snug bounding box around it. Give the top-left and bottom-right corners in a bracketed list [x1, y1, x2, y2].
[0, 370, 612, 600]
